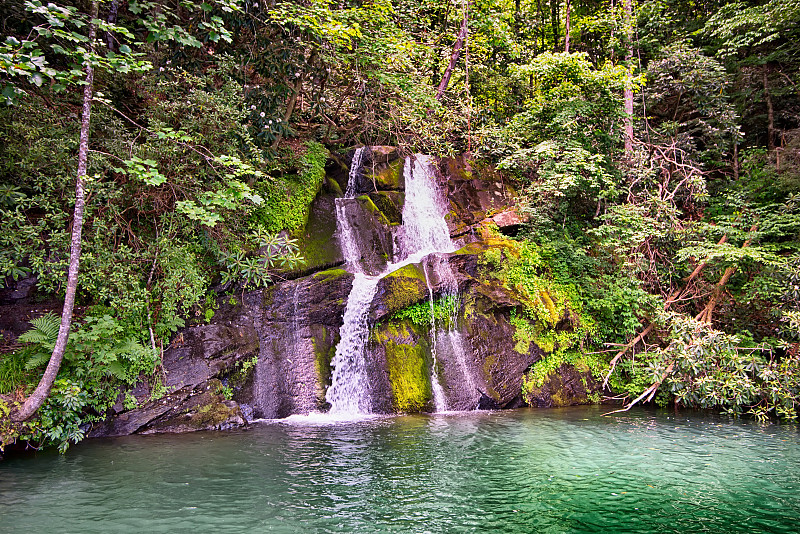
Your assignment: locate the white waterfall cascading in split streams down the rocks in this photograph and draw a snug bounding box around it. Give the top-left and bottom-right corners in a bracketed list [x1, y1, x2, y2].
[326, 148, 471, 417]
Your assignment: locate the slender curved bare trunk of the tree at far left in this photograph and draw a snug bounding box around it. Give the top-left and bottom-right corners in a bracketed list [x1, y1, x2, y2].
[11, 0, 98, 428]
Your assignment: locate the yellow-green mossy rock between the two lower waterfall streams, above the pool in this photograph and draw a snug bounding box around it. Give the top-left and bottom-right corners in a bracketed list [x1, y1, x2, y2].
[373, 321, 433, 413]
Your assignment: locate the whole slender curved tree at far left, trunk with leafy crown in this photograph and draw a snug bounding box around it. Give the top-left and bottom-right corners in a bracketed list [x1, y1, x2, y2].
[0, 0, 241, 422]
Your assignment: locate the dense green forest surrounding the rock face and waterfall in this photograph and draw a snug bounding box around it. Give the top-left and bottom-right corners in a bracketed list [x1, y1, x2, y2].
[0, 0, 800, 456]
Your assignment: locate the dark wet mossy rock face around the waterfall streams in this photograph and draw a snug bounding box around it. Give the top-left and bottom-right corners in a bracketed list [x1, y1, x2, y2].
[91, 147, 592, 436]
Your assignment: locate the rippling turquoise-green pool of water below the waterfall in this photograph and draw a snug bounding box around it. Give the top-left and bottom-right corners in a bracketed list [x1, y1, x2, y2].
[0, 407, 800, 533]
